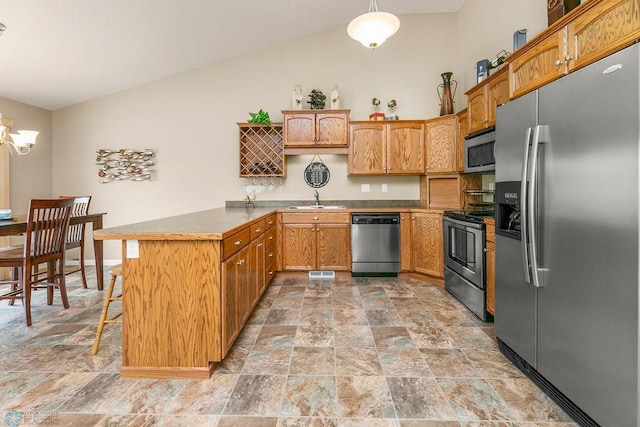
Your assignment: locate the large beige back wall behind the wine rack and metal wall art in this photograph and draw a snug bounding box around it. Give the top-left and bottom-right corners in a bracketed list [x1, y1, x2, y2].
[53, 0, 546, 259]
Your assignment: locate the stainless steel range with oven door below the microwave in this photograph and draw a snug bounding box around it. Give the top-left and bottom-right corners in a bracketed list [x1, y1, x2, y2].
[443, 210, 494, 321]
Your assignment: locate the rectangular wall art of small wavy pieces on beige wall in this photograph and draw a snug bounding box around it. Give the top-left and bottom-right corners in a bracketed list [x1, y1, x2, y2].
[96, 148, 156, 183]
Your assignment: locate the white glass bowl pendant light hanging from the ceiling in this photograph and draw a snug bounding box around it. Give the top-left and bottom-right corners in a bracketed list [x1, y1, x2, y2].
[347, 0, 400, 49]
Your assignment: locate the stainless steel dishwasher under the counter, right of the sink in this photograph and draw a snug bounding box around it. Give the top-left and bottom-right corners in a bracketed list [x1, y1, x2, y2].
[351, 213, 400, 275]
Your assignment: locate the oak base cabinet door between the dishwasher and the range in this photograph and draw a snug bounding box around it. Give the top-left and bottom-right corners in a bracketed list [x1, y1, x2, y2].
[411, 212, 444, 278]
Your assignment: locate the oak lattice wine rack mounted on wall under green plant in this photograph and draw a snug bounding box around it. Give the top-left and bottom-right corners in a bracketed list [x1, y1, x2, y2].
[238, 123, 286, 178]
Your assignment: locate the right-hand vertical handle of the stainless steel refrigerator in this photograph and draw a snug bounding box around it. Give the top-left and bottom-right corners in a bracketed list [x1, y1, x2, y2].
[525, 125, 548, 288]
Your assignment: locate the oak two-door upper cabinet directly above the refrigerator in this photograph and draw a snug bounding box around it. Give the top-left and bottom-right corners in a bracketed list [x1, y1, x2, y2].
[507, 0, 640, 98]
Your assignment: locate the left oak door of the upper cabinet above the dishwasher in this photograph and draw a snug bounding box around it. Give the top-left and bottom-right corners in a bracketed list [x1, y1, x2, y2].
[347, 122, 387, 175]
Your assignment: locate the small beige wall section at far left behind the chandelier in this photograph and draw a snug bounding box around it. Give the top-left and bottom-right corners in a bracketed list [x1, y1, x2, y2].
[0, 97, 53, 213]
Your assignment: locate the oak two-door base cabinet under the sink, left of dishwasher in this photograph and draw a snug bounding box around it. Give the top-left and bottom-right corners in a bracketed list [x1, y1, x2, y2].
[282, 213, 351, 271]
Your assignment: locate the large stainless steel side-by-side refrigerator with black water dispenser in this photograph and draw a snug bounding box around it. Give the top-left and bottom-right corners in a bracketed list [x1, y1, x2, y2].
[495, 44, 640, 427]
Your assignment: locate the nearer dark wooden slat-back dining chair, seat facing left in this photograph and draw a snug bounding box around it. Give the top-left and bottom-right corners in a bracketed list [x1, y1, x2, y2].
[0, 199, 74, 326]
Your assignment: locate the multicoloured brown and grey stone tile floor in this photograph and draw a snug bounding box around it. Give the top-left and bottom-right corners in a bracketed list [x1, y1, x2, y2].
[0, 269, 575, 427]
